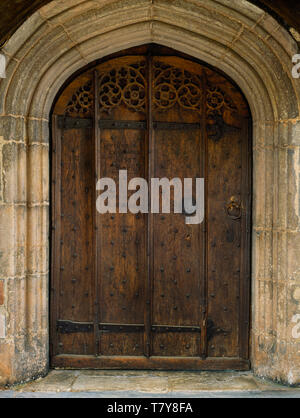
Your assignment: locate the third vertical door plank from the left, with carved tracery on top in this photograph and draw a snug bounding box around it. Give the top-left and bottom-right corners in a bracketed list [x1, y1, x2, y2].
[153, 56, 205, 358]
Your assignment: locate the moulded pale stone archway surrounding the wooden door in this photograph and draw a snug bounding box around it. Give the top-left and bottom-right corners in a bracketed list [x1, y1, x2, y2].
[0, 0, 300, 384]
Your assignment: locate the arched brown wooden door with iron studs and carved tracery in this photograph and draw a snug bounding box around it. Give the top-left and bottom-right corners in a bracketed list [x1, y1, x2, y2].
[51, 48, 251, 370]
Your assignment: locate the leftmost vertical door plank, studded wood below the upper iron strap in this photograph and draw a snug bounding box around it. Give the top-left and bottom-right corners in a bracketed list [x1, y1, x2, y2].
[58, 126, 94, 355]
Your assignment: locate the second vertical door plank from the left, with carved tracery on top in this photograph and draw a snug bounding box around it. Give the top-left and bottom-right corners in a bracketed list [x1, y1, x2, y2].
[98, 56, 148, 358]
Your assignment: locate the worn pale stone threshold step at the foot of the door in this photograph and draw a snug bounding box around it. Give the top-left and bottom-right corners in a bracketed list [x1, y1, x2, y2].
[0, 370, 300, 398]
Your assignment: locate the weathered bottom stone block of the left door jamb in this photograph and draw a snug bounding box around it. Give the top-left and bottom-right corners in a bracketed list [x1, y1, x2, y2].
[4, 274, 49, 381]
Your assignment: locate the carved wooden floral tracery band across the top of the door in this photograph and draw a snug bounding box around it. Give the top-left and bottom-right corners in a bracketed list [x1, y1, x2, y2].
[65, 58, 238, 142]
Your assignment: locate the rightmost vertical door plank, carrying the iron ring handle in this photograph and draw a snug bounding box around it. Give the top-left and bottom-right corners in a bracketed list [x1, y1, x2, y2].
[208, 112, 243, 357]
